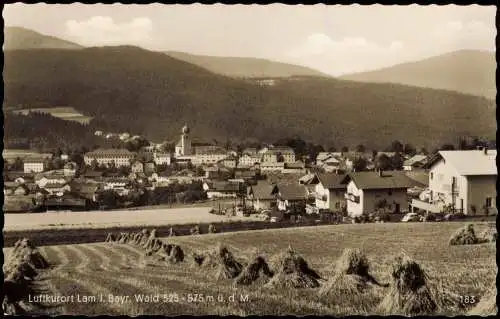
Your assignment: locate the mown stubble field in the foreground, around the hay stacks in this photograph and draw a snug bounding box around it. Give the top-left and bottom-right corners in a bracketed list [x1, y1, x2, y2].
[4, 222, 497, 316]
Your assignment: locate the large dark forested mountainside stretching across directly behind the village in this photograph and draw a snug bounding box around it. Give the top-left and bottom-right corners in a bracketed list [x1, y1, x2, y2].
[4, 46, 496, 147]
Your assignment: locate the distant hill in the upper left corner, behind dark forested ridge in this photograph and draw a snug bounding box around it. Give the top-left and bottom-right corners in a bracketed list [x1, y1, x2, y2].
[4, 27, 83, 50]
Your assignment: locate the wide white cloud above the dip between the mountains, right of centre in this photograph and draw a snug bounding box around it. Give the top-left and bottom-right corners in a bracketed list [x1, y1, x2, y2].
[285, 33, 404, 75]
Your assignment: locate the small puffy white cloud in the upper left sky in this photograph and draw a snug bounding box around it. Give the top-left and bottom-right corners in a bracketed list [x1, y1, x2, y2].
[66, 16, 153, 45]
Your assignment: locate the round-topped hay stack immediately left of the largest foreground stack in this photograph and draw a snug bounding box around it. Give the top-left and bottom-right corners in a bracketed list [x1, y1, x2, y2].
[320, 249, 389, 295]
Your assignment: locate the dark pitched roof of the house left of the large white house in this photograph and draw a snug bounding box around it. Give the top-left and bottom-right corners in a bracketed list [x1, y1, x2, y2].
[342, 171, 415, 189]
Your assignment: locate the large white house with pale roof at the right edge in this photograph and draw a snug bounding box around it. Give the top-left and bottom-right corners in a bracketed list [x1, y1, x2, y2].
[412, 148, 497, 215]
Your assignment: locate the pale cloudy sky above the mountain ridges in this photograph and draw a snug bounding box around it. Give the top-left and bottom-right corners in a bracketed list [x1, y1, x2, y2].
[3, 3, 496, 76]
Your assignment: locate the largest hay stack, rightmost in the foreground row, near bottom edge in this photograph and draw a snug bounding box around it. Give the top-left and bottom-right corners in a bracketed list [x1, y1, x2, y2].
[379, 254, 463, 316]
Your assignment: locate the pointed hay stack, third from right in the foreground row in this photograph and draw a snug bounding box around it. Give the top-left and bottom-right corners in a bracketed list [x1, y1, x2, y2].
[267, 247, 321, 288]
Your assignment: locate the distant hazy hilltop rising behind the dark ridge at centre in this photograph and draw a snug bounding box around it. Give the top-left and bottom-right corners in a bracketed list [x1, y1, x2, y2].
[165, 51, 329, 78]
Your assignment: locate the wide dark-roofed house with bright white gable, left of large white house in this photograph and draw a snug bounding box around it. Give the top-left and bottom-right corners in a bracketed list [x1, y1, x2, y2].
[342, 171, 415, 217]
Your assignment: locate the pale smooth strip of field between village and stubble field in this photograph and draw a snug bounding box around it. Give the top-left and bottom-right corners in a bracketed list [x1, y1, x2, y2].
[4, 207, 262, 231]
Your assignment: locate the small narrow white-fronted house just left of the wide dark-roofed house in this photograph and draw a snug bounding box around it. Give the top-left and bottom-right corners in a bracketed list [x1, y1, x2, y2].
[314, 173, 347, 211]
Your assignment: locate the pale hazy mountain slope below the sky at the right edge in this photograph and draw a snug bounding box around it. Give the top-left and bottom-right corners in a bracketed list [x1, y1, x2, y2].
[340, 50, 496, 100]
